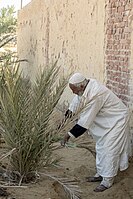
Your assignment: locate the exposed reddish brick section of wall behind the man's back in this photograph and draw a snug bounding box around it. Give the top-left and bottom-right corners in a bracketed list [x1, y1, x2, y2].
[105, 0, 133, 104]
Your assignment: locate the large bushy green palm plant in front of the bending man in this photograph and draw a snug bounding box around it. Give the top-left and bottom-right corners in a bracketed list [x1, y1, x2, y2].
[0, 63, 67, 181]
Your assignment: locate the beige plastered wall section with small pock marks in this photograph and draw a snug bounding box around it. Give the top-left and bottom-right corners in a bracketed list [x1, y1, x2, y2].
[18, 0, 105, 81]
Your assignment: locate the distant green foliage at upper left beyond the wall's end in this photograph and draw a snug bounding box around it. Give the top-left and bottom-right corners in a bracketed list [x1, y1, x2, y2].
[0, 6, 17, 65]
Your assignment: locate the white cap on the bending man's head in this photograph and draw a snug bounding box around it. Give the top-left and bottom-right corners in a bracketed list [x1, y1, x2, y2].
[69, 73, 86, 84]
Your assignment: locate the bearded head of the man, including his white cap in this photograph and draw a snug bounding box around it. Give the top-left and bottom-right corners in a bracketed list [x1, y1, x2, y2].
[69, 73, 88, 96]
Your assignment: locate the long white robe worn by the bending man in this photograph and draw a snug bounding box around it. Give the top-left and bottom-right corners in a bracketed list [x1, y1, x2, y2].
[69, 79, 130, 177]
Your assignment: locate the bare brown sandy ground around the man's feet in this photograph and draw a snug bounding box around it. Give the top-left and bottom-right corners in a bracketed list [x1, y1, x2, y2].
[0, 134, 133, 199]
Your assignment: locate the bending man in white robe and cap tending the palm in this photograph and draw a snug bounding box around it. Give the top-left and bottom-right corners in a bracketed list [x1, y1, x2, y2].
[61, 73, 130, 192]
